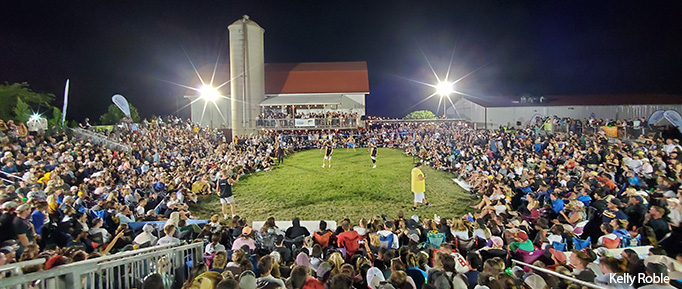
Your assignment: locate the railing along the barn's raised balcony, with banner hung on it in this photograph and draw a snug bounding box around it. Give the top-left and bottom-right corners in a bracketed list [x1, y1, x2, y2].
[256, 117, 364, 129]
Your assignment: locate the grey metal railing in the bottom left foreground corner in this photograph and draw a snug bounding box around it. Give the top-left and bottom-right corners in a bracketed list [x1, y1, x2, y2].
[0, 242, 204, 289]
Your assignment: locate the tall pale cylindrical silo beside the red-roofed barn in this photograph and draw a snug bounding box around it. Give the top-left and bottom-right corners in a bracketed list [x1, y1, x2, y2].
[227, 15, 265, 136]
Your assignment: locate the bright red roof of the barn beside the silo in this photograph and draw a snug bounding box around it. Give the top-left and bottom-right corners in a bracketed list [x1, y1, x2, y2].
[265, 61, 369, 94]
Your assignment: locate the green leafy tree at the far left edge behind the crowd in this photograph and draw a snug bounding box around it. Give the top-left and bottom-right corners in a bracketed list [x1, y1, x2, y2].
[0, 82, 54, 120]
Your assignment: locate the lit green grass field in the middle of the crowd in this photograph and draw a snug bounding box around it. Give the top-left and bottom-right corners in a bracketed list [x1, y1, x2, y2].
[190, 148, 473, 224]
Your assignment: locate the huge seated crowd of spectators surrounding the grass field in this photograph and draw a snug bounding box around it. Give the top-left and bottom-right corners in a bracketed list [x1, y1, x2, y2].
[0, 113, 682, 289]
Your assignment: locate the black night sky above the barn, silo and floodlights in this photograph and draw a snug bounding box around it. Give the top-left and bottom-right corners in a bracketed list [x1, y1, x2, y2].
[0, 0, 682, 121]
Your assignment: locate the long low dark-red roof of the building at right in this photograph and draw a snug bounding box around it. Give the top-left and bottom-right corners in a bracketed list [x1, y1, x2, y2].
[465, 94, 682, 107]
